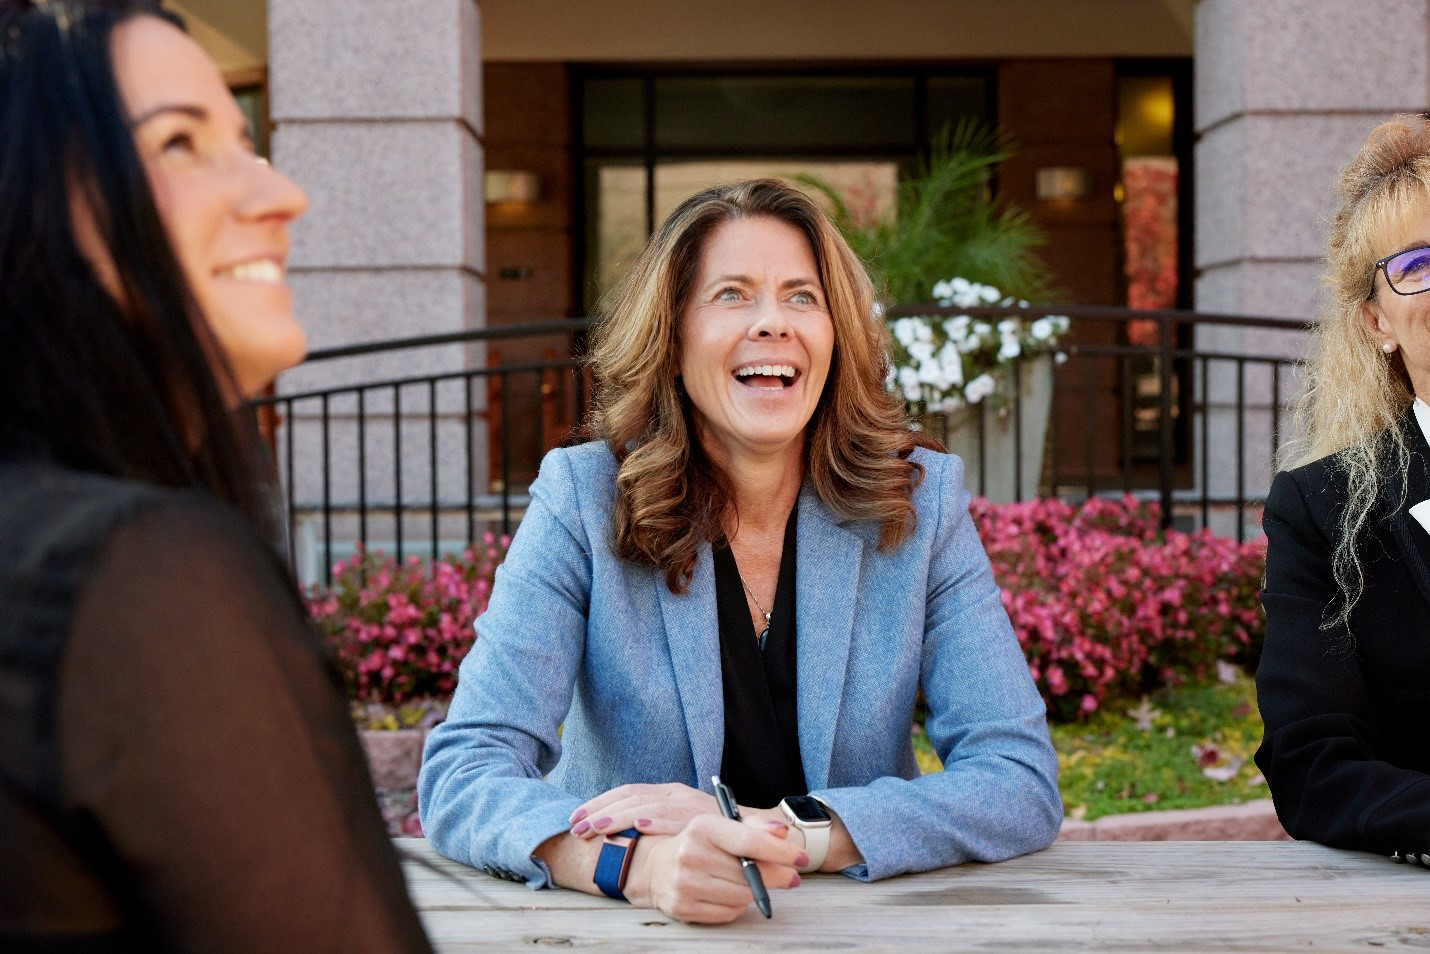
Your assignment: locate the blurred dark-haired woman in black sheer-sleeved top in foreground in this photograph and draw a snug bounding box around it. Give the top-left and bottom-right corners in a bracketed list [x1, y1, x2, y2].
[0, 0, 429, 951]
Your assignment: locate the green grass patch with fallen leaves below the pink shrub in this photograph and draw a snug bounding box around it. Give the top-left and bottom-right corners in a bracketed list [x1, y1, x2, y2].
[914, 674, 1268, 821]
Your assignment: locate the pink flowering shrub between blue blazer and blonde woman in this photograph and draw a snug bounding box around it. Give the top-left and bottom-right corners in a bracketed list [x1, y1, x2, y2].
[972, 498, 1266, 721]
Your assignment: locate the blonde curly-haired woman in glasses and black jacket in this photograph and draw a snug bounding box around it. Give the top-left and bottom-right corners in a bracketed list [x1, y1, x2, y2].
[1257, 116, 1430, 864]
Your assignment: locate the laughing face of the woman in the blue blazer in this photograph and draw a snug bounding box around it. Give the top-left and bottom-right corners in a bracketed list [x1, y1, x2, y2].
[678, 216, 834, 462]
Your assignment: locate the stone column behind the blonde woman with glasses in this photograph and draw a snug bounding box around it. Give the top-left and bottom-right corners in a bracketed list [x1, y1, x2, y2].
[1195, 0, 1430, 535]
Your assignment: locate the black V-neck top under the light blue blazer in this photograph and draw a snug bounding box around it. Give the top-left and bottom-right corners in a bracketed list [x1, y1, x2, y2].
[712, 506, 809, 808]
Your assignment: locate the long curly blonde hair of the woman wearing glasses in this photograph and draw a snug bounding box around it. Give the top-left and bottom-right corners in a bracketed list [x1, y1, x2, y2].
[1281, 114, 1430, 629]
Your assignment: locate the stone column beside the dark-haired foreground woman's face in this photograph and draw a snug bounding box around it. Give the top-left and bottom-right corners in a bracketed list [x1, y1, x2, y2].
[267, 0, 486, 571]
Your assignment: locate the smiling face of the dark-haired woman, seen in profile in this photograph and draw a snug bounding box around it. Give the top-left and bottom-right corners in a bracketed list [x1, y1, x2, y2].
[97, 16, 307, 399]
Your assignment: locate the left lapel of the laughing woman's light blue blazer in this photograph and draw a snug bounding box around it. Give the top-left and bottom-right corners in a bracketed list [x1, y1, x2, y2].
[652, 544, 725, 792]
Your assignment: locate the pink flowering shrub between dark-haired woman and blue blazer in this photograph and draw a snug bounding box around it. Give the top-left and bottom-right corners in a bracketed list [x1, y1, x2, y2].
[307, 533, 509, 705]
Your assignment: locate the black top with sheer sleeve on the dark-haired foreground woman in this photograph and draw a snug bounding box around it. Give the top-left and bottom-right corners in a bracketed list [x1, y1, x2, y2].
[0, 459, 430, 951]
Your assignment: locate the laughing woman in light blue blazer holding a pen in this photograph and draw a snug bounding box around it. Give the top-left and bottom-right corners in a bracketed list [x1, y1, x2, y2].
[419, 180, 1062, 923]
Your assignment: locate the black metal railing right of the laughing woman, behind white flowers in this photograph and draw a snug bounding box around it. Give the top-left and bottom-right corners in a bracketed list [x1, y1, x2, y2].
[888, 305, 1310, 539]
